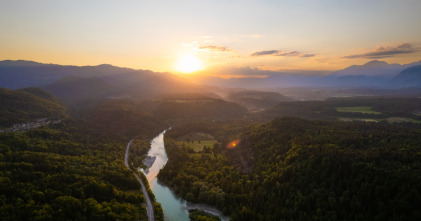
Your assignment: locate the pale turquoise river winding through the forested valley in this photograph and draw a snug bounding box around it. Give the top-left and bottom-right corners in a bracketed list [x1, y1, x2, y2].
[141, 131, 228, 221]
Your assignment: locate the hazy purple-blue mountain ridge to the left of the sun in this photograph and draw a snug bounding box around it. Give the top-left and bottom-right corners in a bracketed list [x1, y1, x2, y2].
[0, 61, 204, 102]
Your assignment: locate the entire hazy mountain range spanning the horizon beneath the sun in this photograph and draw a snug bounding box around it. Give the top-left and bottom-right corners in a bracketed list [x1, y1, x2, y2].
[0, 60, 421, 99]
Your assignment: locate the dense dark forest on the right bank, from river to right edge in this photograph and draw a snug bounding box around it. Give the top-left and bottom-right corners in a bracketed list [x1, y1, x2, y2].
[159, 118, 421, 220]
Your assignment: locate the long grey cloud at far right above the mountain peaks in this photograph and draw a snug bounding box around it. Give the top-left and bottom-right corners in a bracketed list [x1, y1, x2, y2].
[343, 43, 419, 59]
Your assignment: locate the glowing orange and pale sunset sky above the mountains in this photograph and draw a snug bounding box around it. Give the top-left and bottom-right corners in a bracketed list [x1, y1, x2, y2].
[0, 0, 421, 74]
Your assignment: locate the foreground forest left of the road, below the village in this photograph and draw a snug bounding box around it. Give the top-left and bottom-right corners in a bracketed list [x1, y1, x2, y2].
[0, 123, 146, 220]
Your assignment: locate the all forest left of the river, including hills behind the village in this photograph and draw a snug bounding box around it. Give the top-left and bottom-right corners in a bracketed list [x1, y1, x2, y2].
[0, 88, 170, 220]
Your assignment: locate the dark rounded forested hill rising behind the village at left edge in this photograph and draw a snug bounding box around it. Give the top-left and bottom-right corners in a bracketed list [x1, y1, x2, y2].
[0, 88, 67, 127]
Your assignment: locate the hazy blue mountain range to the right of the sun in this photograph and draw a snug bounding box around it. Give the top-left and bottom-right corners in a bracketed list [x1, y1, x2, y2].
[195, 60, 421, 89]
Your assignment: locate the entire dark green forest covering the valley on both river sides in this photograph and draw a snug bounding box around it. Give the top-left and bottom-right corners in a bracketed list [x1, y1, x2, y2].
[0, 88, 421, 220]
